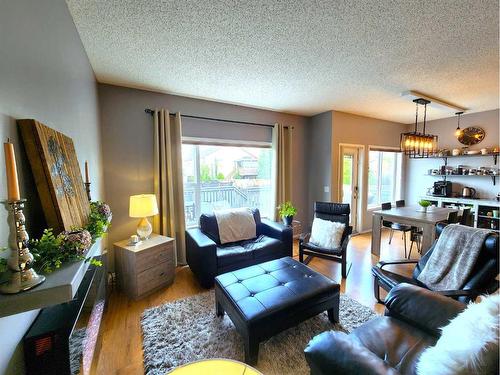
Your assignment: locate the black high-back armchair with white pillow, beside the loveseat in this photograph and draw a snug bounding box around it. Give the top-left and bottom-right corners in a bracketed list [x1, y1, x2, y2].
[299, 202, 352, 279]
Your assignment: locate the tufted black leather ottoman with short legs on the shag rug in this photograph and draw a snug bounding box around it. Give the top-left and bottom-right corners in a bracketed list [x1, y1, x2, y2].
[215, 257, 340, 364]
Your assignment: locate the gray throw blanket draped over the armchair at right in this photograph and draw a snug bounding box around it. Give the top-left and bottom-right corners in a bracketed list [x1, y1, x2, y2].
[417, 224, 490, 290]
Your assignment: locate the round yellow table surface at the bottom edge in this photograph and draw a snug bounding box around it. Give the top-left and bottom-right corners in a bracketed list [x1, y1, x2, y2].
[169, 359, 262, 375]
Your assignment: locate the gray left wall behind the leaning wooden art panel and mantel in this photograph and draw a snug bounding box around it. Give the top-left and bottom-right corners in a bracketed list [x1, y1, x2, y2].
[0, 0, 102, 374]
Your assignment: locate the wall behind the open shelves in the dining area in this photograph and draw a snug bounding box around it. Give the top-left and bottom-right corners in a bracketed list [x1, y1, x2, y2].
[406, 109, 500, 203]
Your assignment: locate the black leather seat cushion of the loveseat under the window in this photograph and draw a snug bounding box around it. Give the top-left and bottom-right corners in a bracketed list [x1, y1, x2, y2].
[217, 234, 283, 267]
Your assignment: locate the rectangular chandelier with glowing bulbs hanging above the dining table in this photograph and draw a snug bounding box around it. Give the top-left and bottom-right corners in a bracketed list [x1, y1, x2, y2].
[400, 98, 438, 159]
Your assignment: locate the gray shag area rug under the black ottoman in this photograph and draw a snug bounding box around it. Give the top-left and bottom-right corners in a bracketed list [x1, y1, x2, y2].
[141, 290, 377, 375]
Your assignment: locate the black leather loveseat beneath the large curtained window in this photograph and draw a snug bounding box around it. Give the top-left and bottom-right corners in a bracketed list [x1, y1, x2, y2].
[186, 210, 292, 288]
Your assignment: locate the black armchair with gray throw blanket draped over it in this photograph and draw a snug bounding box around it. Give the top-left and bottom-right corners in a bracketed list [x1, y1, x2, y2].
[372, 223, 498, 303]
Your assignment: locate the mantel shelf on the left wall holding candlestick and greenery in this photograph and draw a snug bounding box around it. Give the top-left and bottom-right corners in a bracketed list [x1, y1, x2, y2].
[0, 240, 101, 318]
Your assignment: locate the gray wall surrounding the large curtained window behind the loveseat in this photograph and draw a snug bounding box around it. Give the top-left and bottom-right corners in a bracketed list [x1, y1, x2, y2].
[99, 84, 308, 262]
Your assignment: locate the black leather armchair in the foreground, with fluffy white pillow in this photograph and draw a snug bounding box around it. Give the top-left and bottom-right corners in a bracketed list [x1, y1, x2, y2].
[304, 284, 466, 375]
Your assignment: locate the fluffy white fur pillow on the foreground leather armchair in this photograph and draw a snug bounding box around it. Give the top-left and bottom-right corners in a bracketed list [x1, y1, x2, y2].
[417, 294, 500, 375]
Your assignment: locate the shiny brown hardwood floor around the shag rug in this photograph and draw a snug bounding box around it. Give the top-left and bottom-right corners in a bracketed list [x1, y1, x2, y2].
[97, 231, 419, 375]
